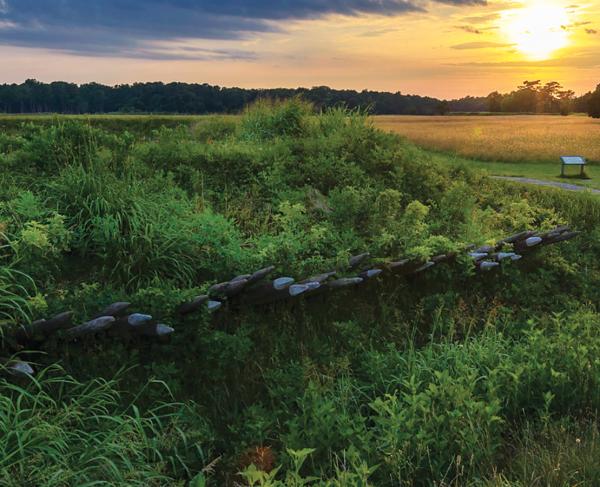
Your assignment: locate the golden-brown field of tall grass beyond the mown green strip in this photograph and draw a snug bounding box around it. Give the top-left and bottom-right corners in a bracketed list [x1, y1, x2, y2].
[373, 115, 600, 162]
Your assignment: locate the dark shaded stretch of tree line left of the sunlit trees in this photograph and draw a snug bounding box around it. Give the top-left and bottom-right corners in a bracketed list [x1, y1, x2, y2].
[0, 79, 439, 115]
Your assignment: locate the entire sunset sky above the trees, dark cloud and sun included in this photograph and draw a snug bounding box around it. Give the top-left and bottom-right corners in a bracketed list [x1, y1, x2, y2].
[0, 0, 600, 98]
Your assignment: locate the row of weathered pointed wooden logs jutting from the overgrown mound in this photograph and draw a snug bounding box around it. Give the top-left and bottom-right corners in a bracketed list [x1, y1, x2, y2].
[4, 226, 579, 376]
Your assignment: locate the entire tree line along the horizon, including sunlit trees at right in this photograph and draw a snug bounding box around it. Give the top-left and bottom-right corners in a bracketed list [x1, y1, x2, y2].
[0, 79, 600, 117]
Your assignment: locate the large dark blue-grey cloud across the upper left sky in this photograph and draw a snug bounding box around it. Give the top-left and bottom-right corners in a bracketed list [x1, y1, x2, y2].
[0, 0, 486, 59]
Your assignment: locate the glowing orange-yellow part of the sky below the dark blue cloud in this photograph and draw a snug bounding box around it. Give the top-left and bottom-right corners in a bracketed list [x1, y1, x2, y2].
[0, 0, 600, 98]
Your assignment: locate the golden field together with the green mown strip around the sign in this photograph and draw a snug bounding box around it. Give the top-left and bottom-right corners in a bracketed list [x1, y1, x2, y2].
[374, 115, 600, 194]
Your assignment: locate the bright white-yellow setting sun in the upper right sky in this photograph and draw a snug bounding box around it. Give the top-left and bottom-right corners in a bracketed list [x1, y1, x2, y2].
[501, 2, 570, 61]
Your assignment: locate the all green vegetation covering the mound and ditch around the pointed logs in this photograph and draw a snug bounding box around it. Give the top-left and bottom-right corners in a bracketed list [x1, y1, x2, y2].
[0, 99, 600, 487]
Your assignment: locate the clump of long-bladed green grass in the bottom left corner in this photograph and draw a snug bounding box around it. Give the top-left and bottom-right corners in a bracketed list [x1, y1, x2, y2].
[0, 366, 208, 487]
